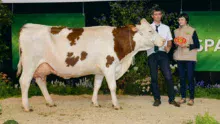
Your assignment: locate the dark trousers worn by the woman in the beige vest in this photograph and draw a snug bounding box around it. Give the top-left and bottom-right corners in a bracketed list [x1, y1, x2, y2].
[177, 61, 196, 99]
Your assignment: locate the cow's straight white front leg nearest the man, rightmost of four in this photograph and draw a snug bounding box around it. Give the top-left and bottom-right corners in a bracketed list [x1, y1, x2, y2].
[105, 72, 121, 110]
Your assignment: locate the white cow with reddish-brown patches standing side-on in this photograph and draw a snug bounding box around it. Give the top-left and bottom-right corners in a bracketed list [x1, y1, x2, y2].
[17, 19, 165, 112]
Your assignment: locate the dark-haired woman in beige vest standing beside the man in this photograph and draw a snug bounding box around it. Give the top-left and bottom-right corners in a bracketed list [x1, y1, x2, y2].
[174, 13, 200, 106]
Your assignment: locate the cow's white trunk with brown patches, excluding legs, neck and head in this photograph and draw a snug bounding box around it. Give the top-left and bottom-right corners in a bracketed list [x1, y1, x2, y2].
[20, 24, 117, 77]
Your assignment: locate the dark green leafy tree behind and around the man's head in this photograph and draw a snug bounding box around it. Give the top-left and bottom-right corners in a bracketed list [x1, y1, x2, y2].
[94, 0, 178, 31]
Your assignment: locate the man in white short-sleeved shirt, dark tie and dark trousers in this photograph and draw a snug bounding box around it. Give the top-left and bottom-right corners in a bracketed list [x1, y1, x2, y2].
[147, 8, 180, 107]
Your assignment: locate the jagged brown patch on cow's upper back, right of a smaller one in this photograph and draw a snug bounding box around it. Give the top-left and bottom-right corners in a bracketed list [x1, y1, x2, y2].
[67, 28, 84, 46]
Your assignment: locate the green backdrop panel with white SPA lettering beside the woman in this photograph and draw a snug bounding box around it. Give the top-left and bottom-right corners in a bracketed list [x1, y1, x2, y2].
[187, 11, 220, 71]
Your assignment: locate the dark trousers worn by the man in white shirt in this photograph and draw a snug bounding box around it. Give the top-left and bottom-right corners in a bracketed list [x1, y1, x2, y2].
[148, 51, 175, 102]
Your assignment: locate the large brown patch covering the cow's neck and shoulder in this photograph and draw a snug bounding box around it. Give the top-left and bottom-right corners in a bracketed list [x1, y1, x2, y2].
[112, 25, 136, 60]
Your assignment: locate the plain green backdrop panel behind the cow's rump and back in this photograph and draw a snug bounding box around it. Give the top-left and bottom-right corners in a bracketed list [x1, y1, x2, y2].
[12, 13, 85, 70]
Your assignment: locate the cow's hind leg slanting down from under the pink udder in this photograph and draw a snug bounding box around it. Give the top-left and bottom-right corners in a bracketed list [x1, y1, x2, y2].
[36, 77, 56, 107]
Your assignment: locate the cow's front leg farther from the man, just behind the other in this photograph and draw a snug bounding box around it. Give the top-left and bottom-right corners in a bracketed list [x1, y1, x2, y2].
[92, 75, 104, 107]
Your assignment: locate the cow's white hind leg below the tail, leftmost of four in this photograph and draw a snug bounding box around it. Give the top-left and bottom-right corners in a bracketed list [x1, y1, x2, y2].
[19, 71, 33, 112]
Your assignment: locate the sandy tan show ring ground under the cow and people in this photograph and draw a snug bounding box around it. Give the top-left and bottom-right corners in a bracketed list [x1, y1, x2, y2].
[0, 95, 220, 124]
